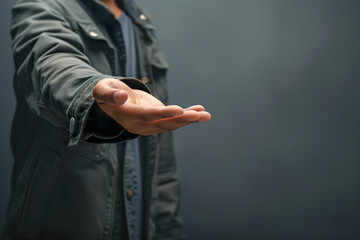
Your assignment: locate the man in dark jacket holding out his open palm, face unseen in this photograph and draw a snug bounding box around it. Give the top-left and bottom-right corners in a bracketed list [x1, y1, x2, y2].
[4, 0, 210, 240]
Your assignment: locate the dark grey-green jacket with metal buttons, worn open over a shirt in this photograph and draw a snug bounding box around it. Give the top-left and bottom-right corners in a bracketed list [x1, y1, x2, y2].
[3, 0, 184, 240]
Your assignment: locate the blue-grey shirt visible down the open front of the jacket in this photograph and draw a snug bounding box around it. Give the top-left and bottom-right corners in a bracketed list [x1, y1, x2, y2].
[112, 12, 143, 240]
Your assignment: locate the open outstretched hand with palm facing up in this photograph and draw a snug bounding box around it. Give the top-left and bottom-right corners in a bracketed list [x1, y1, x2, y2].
[93, 78, 211, 135]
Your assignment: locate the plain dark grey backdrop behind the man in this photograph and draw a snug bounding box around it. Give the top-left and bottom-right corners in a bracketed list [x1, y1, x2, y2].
[0, 0, 360, 240]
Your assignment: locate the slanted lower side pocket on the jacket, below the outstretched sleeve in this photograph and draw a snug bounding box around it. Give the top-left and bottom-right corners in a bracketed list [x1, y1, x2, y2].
[19, 148, 61, 238]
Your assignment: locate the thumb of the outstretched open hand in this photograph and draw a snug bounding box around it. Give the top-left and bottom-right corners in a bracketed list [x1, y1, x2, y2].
[93, 79, 129, 105]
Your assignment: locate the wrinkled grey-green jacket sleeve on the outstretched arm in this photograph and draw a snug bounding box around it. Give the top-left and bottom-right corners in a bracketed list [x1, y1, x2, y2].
[11, 0, 146, 146]
